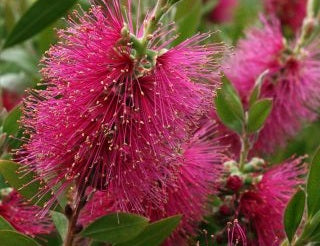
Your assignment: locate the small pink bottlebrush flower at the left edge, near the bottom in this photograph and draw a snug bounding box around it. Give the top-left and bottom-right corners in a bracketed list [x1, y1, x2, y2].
[0, 188, 54, 236]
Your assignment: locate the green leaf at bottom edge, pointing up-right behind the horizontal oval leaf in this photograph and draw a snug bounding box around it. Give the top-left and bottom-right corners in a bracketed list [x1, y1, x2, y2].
[117, 215, 181, 246]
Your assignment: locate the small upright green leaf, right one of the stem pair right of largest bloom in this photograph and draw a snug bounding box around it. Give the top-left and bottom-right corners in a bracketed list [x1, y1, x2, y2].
[247, 99, 272, 133]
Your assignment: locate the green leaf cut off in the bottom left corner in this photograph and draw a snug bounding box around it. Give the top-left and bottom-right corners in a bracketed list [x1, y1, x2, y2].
[0, 230, 40, 246]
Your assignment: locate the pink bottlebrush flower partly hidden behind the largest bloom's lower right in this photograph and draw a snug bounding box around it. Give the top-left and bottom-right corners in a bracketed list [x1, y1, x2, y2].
[152, 124, 225, 245]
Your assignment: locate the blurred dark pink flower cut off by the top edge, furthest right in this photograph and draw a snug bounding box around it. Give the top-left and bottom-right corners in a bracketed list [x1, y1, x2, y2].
[264, 0, 308, 32]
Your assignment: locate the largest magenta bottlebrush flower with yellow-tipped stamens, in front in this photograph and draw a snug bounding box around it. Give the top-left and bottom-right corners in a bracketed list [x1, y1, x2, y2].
[17, 0, 221, 210]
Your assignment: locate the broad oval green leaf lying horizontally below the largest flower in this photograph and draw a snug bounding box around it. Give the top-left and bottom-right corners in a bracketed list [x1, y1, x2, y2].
[81, 213, 148, 243]
